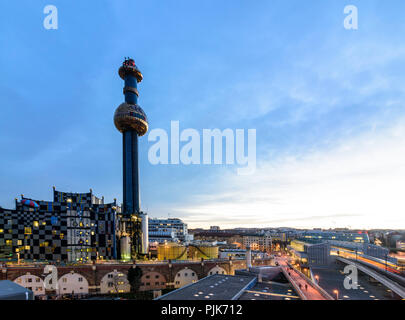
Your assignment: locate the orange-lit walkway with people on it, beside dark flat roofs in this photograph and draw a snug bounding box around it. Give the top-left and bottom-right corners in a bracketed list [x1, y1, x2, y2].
[276, 257, 334, 300]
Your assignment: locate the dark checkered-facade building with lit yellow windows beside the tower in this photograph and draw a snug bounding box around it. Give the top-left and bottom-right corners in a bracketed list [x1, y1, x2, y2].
[0, 189, 118, 262]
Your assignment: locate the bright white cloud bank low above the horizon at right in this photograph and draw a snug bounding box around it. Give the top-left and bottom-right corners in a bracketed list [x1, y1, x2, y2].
[176, 119, 405, 228]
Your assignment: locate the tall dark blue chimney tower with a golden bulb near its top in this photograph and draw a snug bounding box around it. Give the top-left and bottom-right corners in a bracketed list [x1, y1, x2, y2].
[114, 58, 148, 260]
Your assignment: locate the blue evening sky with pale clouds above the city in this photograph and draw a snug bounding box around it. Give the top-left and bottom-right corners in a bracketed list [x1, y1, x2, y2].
[0, 0, 405, 229]
